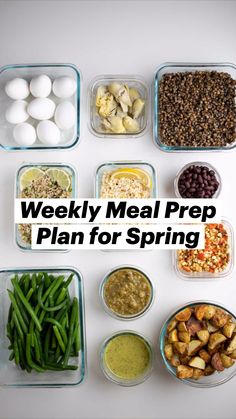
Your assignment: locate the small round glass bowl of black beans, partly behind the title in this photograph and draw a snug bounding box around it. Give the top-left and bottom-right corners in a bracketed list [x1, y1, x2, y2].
[174, 162, 221, 198]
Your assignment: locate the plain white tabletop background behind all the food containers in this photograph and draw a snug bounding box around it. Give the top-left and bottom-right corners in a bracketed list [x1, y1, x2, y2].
[0, 1, 236, 419]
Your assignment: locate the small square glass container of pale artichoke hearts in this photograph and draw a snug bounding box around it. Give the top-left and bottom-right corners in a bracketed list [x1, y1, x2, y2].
[88, 75, 149, 139]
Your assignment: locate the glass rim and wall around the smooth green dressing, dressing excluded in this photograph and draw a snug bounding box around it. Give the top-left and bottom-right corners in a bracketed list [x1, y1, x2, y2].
[99, 330, 153, 387]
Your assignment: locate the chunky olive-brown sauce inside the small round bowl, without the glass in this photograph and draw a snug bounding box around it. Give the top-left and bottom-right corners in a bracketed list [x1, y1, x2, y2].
[103, 268, 151, 316]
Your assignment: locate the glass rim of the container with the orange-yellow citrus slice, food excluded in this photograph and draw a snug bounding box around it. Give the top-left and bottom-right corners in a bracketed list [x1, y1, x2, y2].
[95, 161, 157, 198]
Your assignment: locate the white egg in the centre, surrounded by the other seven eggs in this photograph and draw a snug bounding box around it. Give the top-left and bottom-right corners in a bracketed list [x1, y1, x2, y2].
[27, 98, 56, 121]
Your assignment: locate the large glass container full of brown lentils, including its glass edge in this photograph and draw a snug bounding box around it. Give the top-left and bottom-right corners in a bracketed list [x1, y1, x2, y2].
[153, 63, 236, 152]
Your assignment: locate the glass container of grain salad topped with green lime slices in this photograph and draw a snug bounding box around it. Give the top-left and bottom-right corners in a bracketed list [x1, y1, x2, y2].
[15, 163, 77, 251]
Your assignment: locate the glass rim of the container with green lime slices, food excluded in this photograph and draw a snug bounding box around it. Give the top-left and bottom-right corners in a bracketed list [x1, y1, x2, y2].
[14, 163, 77, 252]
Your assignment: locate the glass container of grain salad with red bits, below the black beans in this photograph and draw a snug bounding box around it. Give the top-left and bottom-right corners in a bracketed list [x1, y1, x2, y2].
[173, 219, 234, 281]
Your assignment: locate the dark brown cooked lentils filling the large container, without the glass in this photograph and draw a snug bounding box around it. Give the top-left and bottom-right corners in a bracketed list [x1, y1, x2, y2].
[159, 71, 236, 147]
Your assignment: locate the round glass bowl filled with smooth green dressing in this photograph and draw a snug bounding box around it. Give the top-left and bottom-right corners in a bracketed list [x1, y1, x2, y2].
[100, 330, 153, 387]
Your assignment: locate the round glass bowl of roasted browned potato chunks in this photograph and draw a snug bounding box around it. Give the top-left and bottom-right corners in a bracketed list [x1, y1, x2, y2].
[159, 301, 236, 388]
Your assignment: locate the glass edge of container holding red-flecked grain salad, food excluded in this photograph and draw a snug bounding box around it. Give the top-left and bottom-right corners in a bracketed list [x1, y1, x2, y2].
[172, 219, 234, 282]
